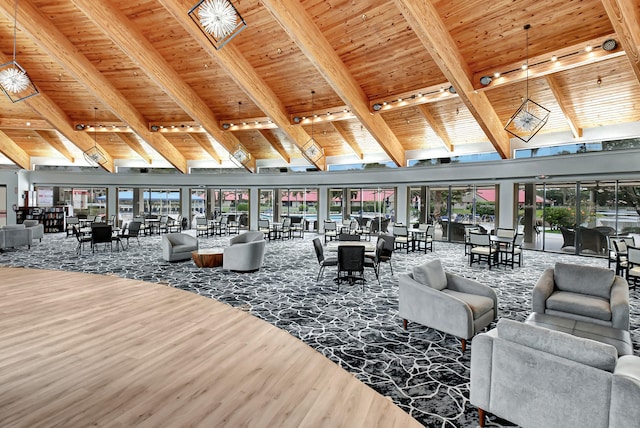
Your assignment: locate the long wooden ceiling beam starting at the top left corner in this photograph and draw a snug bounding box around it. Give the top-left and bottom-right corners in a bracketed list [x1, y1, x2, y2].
[0, 0, 187, 173]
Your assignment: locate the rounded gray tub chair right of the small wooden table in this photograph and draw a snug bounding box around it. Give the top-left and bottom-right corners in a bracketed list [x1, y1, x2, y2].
[222, 230, 266, 272]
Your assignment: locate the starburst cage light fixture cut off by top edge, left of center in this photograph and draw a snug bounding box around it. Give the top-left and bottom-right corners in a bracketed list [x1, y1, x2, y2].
[189, 0, 247, 50]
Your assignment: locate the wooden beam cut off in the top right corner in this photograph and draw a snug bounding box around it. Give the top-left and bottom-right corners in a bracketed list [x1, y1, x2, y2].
[602, 0, 640, 82]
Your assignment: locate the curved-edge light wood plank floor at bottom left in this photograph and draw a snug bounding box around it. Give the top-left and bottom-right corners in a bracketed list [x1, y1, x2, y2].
[0, 268, 421, 428]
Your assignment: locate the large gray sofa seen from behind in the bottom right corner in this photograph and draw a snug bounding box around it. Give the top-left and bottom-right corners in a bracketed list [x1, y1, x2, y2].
[469, 319, 640, 428]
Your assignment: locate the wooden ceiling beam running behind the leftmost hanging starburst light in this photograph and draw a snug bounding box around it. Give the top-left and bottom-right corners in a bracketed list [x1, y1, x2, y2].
[0, 50, 115, 172]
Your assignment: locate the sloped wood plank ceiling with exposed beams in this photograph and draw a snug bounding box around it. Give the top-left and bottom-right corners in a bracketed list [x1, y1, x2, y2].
[0, 0, 640, 173]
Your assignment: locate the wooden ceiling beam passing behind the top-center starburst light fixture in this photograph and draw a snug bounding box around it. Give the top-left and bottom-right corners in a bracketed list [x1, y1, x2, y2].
[159, 0, 326, 171]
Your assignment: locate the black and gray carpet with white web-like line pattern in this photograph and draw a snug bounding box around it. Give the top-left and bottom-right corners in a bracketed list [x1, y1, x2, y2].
[0, 232, 640, 427]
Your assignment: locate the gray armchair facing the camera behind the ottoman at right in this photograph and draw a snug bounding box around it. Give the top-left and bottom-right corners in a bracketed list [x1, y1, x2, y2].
[532, 263, 629, 330]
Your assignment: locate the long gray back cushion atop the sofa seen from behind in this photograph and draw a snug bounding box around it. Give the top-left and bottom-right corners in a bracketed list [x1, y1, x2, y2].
[497, 318, 618, 372]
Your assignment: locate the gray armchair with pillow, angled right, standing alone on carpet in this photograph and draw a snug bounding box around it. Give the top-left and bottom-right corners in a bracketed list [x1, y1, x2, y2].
[398, 260, 498, 352]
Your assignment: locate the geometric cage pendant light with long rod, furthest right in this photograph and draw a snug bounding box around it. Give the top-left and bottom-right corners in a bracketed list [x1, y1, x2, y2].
[504, 24, 550, 143]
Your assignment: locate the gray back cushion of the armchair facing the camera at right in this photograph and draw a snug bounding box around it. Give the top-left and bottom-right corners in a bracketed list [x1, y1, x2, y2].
[553, 263, 615, 300]
